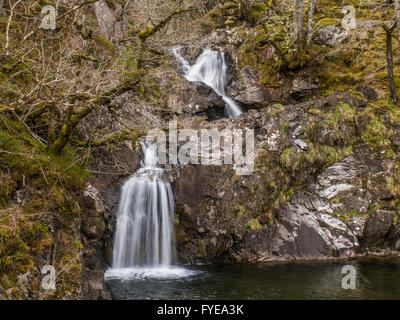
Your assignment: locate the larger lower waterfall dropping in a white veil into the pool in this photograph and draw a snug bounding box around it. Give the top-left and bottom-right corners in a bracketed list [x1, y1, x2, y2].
[113, 143, 175, 269]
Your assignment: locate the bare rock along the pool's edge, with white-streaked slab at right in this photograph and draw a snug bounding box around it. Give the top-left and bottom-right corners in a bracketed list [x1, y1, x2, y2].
[175, 147, 398, 262]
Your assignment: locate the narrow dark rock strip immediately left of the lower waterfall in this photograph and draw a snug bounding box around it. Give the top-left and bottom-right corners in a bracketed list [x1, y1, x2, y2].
[77, 142, 140, 299]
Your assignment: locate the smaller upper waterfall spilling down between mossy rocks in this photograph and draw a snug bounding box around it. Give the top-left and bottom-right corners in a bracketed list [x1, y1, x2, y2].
[173, 48, 243, 118]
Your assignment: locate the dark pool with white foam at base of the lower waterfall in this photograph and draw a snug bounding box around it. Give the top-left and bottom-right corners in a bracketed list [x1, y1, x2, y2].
[106, 258, 400, 300]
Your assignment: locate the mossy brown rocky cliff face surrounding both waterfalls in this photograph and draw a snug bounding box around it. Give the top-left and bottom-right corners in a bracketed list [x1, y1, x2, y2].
[0, 1, 400, 299]
